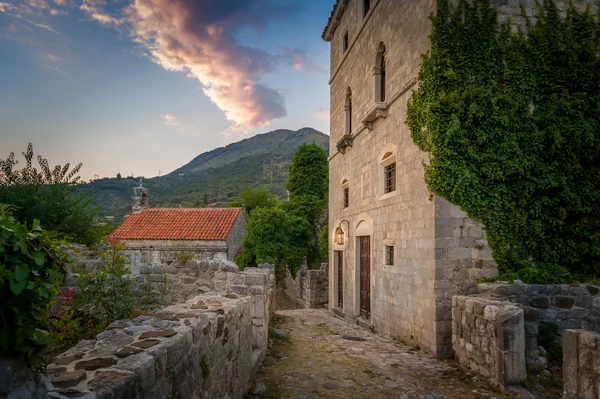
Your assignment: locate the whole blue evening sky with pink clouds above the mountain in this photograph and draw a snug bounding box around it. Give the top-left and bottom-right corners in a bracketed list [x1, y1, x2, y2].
[0, 0, 335, 180]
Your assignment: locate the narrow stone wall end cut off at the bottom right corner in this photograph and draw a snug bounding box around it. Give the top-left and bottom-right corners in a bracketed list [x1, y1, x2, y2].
[563, 330, 600, 399]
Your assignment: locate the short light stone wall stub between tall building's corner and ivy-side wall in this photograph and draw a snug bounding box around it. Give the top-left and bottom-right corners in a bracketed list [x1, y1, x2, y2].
[452, 296, 527, 387]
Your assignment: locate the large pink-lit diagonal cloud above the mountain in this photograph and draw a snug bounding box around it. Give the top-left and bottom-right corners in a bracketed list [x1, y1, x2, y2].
[118, 0, 286, 130]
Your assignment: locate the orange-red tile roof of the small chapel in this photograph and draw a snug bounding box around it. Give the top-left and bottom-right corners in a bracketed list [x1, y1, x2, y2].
[107, 208, 241, 241]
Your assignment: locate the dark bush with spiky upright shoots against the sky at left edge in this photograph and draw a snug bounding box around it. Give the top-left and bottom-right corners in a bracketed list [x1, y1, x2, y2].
[0, 144, 110, 245]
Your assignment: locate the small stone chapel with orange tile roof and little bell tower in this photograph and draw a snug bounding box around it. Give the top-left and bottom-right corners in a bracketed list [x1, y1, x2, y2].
[107, 185, 246, 273]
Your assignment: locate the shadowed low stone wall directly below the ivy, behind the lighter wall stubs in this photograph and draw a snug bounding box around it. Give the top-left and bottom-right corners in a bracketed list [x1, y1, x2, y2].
[477, 284, 600, 373]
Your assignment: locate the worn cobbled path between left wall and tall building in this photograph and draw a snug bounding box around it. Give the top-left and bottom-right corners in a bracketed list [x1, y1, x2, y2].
[248, 309, 504, 399]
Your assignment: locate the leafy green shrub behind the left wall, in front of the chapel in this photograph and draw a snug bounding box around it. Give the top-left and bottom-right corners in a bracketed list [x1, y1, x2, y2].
[75, 242, 134, 321]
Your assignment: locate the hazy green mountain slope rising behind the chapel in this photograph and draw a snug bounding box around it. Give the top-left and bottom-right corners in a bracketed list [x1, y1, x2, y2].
[82, 128, 329, 219]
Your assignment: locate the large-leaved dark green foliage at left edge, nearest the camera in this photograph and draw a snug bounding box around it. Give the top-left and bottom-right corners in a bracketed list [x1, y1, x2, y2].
[0, 205, 68, 367]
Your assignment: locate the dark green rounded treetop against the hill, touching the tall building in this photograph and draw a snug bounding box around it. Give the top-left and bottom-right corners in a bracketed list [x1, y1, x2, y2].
[286, 143, 329, 199]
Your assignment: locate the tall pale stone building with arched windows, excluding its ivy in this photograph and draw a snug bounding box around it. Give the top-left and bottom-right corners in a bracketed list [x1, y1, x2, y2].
[322, 0, 598, 356]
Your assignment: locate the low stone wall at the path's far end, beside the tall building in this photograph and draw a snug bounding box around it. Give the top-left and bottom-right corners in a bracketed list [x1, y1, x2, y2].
[277, 263, 329, 309]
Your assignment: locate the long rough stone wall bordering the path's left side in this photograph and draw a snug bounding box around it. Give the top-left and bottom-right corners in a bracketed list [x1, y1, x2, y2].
[0, 261, 275, 399]
